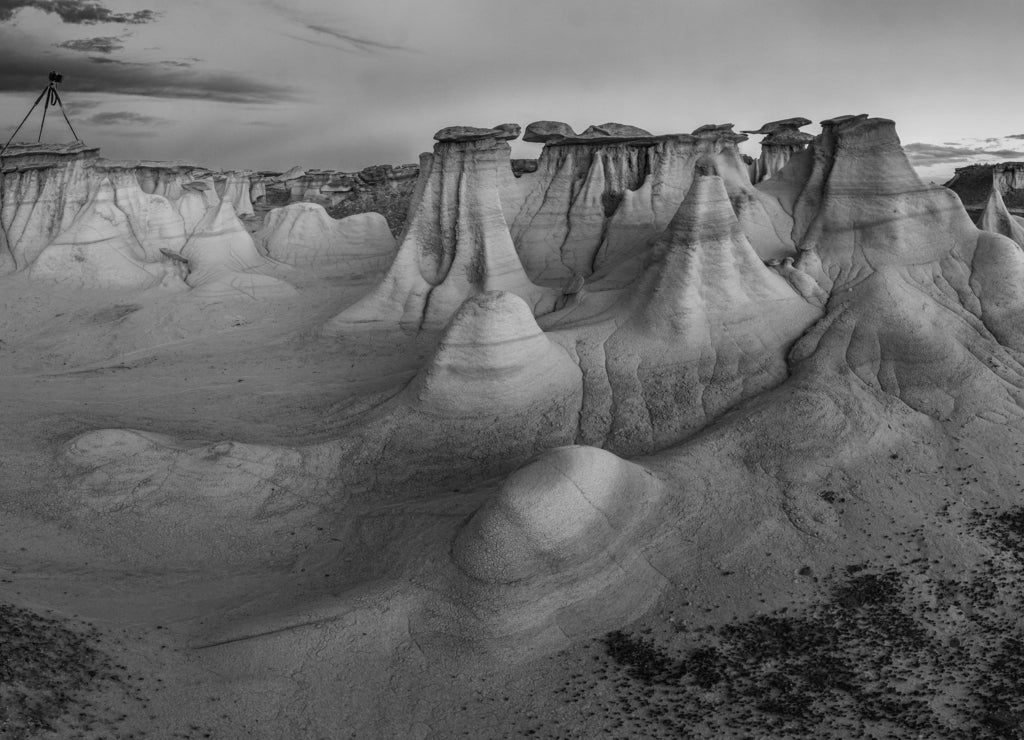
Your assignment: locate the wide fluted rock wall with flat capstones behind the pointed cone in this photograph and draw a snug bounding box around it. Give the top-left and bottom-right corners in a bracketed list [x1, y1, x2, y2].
[505, 121, 793, 280]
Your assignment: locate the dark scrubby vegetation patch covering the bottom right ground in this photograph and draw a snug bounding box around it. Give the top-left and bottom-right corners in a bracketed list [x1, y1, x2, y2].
[537, 515, 1024, 740]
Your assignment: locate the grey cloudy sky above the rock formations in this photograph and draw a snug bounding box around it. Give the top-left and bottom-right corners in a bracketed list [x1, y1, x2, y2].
[0, 0, 1024, 182]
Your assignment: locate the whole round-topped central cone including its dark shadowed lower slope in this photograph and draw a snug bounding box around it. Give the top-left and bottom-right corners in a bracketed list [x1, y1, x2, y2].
[352, 291, 583, 491]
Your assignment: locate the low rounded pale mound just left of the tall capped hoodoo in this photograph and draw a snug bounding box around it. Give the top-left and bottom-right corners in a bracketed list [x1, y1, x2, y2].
[255, 203, 395, 273]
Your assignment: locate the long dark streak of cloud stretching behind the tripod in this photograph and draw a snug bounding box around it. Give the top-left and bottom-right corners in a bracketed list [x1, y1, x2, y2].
[0, 46, 294, 103]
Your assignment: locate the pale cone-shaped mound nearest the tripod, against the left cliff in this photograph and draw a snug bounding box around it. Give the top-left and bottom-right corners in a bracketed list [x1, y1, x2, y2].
[29, 178, 180, 290]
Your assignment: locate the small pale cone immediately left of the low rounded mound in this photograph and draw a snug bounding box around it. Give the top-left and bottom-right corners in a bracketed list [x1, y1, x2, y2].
[181, 201, 295, 299]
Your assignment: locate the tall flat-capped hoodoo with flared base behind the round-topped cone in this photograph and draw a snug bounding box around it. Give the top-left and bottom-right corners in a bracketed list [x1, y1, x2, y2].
[324, 124, 559, 335]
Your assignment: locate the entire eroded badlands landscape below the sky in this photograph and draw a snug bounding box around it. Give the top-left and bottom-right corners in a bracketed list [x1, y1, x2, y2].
[0, 115, 1024, 738]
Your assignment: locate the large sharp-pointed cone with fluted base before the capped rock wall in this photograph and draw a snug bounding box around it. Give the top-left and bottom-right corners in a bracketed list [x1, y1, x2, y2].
[544, 174, 821, 454]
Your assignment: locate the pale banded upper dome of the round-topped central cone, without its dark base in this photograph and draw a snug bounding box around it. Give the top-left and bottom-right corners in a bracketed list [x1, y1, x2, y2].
[406, 291, 581, 415]
